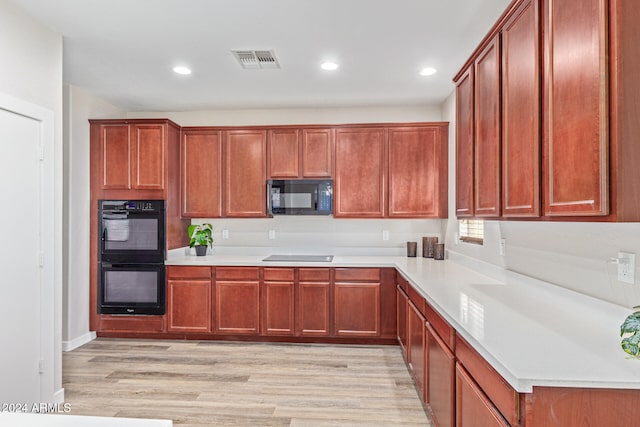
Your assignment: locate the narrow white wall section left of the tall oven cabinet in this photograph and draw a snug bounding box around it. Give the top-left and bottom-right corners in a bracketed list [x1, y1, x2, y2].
[62, 85, 125, 351]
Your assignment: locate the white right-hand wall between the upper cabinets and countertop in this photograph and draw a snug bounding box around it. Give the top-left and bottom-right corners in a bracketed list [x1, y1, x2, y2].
[442, 93, 640, 307]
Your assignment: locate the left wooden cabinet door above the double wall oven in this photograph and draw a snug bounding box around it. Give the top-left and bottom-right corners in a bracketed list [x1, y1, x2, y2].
[100, 124, 131, 190]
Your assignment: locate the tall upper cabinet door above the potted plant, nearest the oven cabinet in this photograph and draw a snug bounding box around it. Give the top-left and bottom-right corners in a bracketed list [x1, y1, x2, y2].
[180, 130, 222, 218]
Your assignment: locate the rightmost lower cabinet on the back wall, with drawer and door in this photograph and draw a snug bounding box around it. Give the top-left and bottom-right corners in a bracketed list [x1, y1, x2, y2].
[333, 268, 380, 337]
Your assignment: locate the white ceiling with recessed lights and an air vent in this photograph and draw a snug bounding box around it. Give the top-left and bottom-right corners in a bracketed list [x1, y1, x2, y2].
[13, 0, 510, 112]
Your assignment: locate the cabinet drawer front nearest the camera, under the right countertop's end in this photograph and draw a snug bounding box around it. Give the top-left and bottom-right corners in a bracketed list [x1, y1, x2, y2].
[455, 336, 520, 426]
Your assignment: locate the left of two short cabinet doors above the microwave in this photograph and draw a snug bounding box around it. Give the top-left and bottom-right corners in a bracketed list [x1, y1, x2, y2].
[269, 129, 300, 179]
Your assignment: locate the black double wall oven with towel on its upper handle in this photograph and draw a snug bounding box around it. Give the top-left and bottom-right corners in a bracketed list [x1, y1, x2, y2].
[98, 200, 166, 315]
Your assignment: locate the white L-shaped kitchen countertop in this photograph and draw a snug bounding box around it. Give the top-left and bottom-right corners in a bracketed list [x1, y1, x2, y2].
[166, 251, 640, 392]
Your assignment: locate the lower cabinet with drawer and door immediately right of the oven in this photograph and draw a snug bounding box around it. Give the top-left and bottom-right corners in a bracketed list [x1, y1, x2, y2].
[167, 266, 212, 332]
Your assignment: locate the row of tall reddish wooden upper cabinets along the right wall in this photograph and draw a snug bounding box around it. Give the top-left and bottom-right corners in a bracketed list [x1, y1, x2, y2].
[454, 0, 640, 221]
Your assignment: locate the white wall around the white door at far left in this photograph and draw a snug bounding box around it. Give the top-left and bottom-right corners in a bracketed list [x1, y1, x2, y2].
[0, 0, 63, 401]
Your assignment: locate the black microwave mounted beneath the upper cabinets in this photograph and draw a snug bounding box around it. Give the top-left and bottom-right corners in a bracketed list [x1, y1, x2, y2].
[267, 179, 333, 215]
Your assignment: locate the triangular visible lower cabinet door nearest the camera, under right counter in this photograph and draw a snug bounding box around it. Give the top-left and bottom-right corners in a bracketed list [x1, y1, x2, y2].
[456, 364, 509, 427]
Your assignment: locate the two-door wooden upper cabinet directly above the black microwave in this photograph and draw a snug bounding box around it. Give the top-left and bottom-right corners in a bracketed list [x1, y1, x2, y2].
[268, 128, 334, 179]
